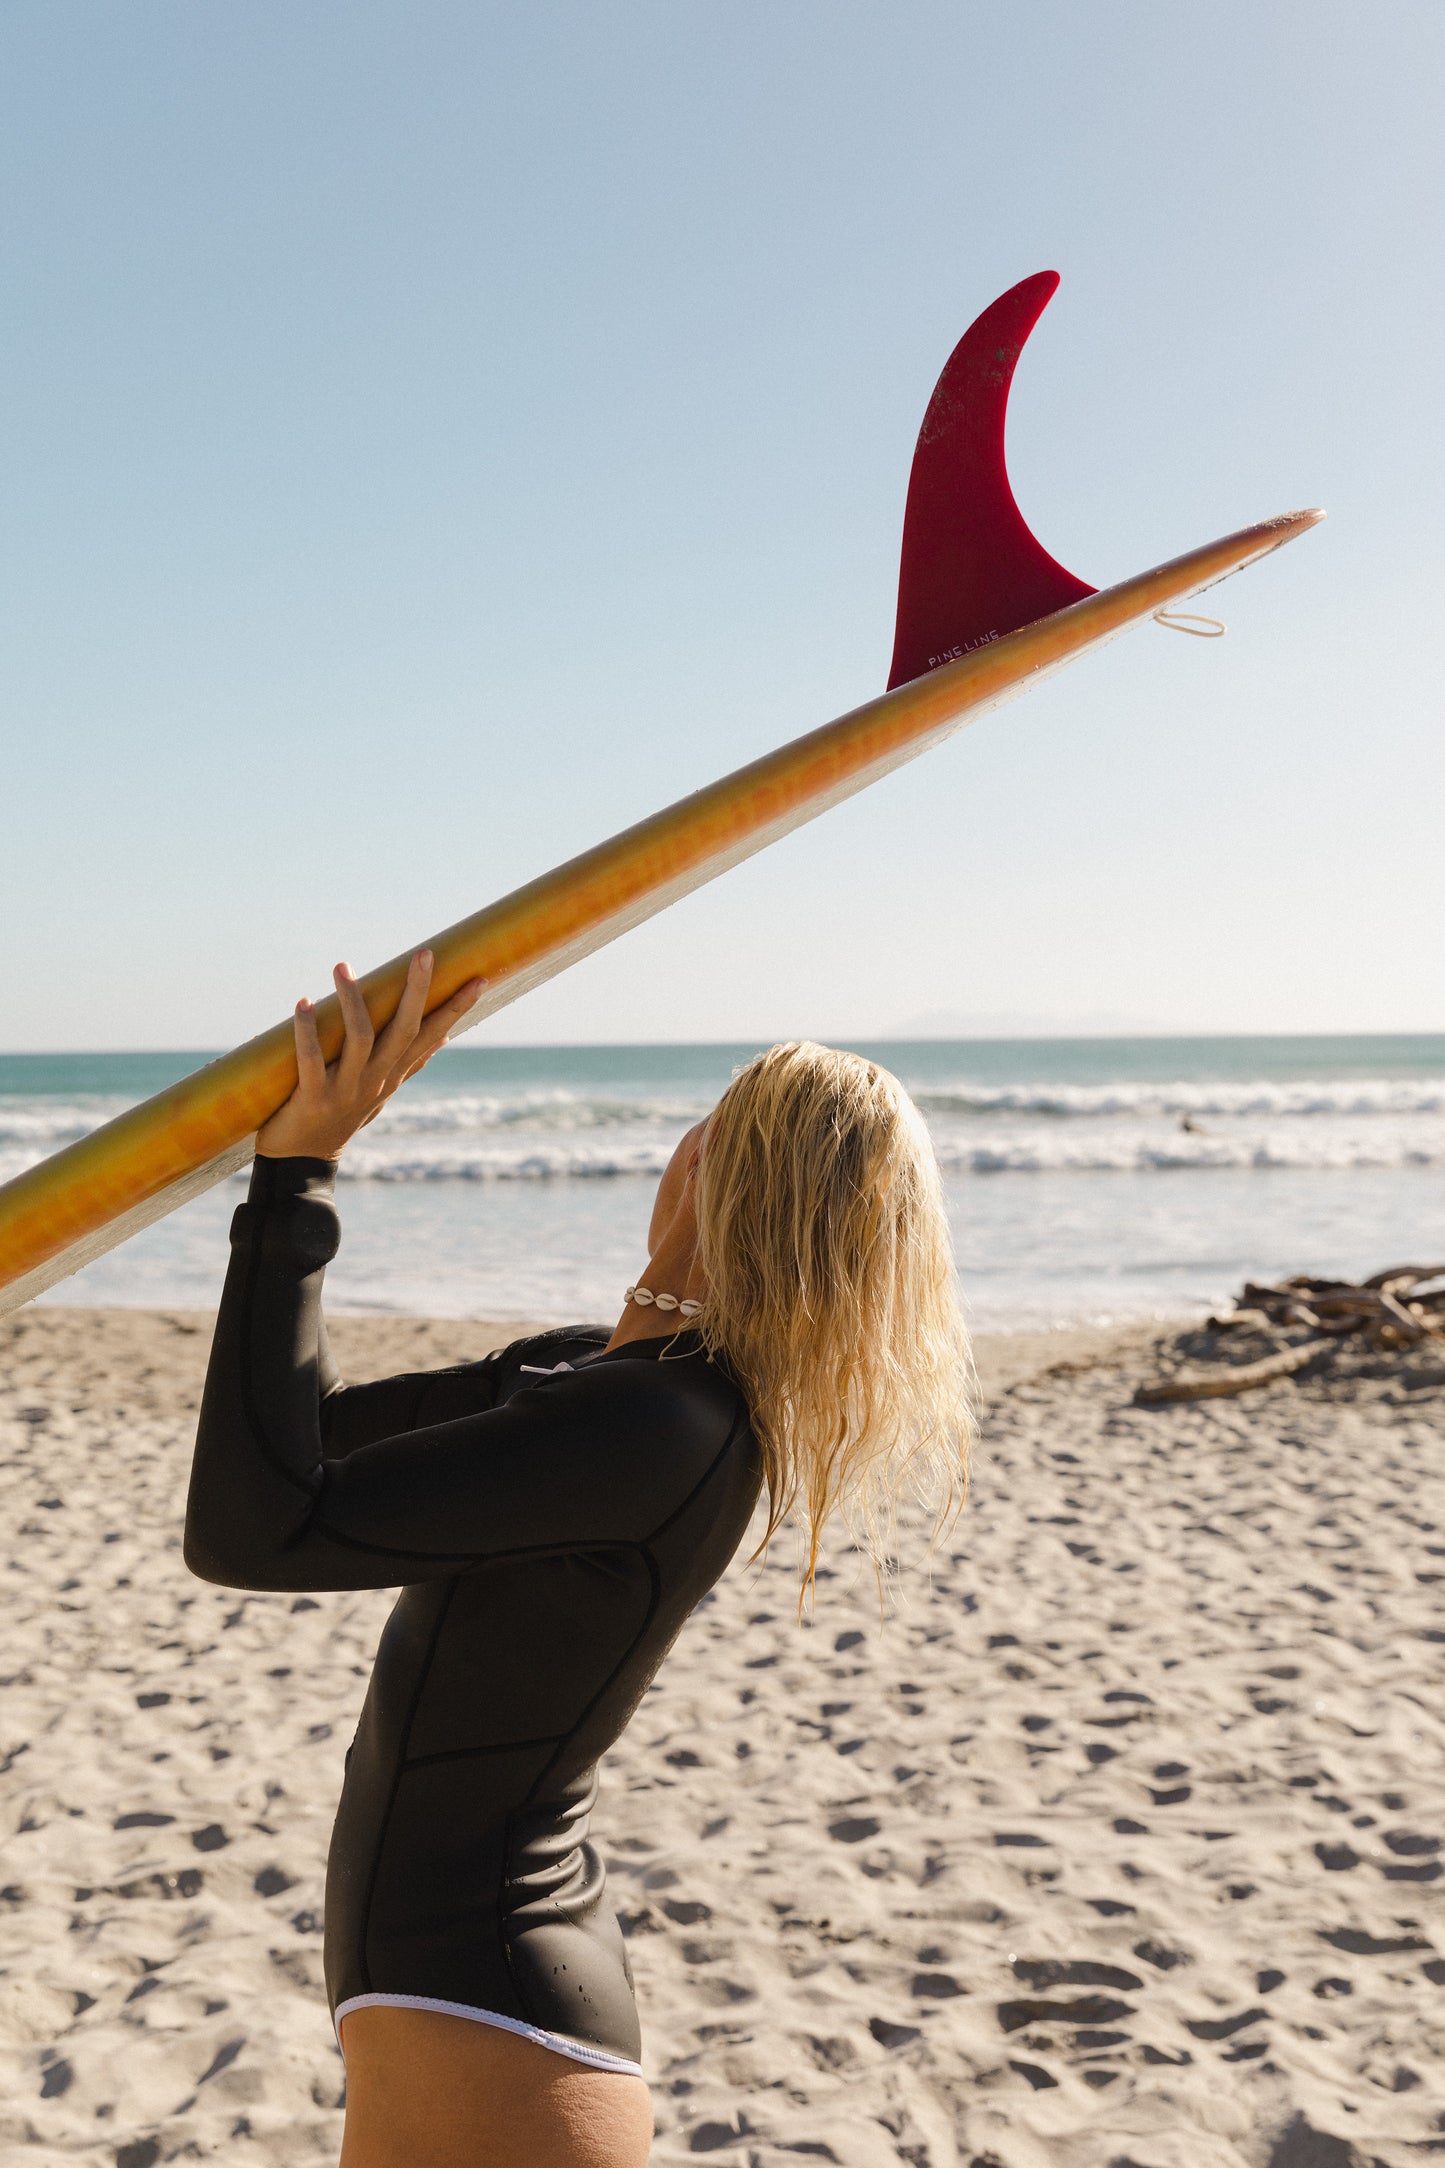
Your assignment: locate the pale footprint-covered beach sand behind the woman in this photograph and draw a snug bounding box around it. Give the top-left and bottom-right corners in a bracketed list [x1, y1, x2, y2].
[0, 1309, 1445, 2168]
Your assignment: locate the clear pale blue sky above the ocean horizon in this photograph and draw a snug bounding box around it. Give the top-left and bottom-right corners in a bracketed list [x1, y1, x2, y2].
[0, 0, 1445, 1049]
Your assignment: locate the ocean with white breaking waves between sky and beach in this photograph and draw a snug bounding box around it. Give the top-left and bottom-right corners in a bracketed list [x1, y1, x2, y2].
[0, 1034, 1445, 1331]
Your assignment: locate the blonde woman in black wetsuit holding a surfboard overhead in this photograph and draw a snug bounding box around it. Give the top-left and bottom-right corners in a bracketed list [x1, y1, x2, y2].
[186, 952, 968, 2168]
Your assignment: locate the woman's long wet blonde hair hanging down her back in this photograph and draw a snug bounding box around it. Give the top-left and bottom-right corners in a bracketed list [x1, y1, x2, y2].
[695, 1041, 975, 1596]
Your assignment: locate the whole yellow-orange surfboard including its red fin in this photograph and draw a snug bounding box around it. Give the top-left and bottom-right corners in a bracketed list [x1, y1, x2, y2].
[0, 271, 1324, 1312]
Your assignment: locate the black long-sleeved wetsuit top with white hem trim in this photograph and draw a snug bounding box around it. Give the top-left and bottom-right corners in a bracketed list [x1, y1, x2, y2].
[186, 1160, 760, 2068]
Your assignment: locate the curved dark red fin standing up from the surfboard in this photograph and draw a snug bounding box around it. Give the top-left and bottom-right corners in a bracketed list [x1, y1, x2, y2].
[888, 271, 1096, 692]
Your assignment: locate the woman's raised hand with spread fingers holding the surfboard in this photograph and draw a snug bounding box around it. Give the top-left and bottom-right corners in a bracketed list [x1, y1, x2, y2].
[256, 950, 485, 1160]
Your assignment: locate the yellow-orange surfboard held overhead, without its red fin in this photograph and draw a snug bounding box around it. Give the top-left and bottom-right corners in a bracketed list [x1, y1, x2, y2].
[0, 509, 1324, 1312]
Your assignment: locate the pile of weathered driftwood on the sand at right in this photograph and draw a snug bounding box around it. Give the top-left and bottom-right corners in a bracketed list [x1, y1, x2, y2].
[1135, 1264, 1445, 1407]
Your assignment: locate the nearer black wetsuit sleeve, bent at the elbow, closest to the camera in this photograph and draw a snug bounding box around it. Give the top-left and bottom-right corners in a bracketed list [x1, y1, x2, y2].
[186, 1160, 726, 1589]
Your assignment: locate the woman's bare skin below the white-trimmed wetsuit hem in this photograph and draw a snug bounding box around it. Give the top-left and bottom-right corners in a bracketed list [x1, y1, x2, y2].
[340, 2005, 652, 2168]
